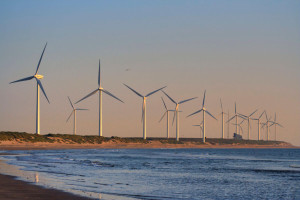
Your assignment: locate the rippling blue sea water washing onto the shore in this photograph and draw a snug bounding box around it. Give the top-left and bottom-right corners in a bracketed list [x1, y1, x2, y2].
[0, 149, 300, 200]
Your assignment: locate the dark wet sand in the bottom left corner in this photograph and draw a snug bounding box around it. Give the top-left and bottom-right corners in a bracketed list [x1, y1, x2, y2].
[0, 174, 90, 200]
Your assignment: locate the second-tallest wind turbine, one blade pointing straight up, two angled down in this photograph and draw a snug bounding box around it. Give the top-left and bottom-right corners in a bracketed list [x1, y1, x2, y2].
[75, 60, 124, 136]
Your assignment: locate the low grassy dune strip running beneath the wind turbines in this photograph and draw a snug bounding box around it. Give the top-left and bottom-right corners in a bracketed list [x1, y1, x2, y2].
[0, 132, 288, 145]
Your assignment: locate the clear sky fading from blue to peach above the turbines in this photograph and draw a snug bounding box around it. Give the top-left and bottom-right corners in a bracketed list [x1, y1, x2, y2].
[0, 0, 300, 146]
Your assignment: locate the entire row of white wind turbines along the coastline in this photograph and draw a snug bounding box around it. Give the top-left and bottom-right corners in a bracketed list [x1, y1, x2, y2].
[10, 43, 283, 142]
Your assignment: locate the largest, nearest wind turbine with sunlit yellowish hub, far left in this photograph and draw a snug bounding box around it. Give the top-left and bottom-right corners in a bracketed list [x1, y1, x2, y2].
[10, 43, 50, 134]
